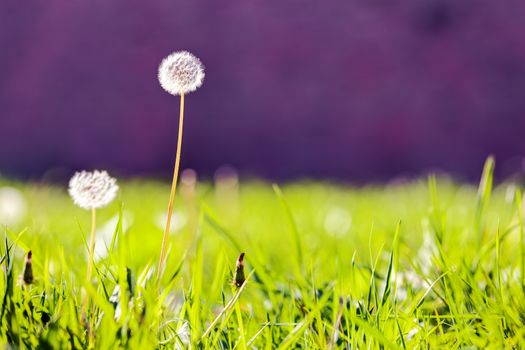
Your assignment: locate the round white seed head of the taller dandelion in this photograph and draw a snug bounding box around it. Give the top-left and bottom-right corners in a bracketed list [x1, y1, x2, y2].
[159, 51, 204, 95]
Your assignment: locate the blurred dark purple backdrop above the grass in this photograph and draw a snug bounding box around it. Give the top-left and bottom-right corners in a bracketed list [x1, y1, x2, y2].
[0, 0, 525, 182]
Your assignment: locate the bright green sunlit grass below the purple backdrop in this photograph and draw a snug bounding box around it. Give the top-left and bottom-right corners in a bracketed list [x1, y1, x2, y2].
[0, 161, 525, 349]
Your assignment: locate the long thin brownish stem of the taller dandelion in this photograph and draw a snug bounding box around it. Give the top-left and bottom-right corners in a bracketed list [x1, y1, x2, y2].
[157, 91, 184, 285]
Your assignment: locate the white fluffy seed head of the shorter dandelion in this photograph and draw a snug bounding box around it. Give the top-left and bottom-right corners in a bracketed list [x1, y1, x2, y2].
[69, 170, 118, 209]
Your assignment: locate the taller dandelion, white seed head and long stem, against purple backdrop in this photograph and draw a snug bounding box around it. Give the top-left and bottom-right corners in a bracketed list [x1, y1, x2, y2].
[157, 51, 204, 283]
